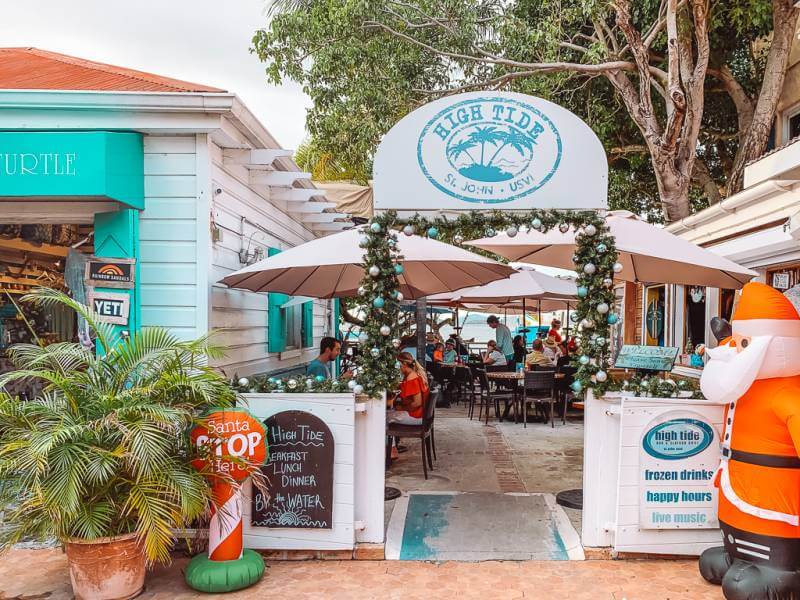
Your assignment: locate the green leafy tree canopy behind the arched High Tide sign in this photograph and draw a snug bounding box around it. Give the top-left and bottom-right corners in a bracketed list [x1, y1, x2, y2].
[260, 0, 784, 221]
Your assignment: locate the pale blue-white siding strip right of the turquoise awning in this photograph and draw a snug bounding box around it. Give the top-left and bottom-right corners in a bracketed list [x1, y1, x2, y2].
[139, 136, 200, 339]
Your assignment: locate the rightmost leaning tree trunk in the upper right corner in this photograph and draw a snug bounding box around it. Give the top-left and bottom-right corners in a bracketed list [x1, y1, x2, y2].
[728, 0, 800, 195]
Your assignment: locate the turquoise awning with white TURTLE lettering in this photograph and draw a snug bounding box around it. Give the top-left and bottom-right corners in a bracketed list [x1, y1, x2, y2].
[0, 131, 144, 210]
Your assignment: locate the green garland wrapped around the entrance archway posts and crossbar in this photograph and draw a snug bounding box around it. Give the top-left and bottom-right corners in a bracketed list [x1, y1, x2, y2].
[356, 210, 617, 396]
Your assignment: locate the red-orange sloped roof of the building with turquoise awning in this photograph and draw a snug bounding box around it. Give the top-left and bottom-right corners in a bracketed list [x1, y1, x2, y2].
[0, 48, 225, 92]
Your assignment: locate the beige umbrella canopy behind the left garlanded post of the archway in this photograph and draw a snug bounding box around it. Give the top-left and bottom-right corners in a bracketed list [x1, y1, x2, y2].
[222, 228, 514, 299]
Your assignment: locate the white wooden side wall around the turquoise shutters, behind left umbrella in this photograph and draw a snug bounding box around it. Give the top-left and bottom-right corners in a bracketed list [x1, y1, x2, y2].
[208, 143, 329, 376]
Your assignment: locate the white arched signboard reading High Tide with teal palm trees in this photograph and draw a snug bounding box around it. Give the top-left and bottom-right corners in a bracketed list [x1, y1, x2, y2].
[373, 92, 608, 211]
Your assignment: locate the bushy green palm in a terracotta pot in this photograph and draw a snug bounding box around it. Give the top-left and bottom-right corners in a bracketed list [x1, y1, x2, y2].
[0, 289, 235, 600]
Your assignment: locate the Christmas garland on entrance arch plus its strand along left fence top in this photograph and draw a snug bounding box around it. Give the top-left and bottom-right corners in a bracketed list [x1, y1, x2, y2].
[232, 210, 622, 397]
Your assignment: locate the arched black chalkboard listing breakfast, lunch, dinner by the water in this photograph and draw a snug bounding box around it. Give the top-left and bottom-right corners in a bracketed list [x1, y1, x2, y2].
[252, 410, 334, 529]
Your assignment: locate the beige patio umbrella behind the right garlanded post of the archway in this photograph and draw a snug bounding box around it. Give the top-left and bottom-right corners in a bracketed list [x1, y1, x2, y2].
[469, 210, 757, 289]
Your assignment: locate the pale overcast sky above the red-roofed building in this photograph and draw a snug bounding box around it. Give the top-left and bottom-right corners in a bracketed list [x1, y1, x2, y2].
[0, 0, 311, 150]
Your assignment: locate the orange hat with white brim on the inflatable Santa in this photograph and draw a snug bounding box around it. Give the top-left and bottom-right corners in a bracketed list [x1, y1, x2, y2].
[731, 282, 800, 337]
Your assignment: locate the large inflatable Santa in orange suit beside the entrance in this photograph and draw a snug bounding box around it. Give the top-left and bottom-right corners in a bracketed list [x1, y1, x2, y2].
[700, 283, 800, 600]
